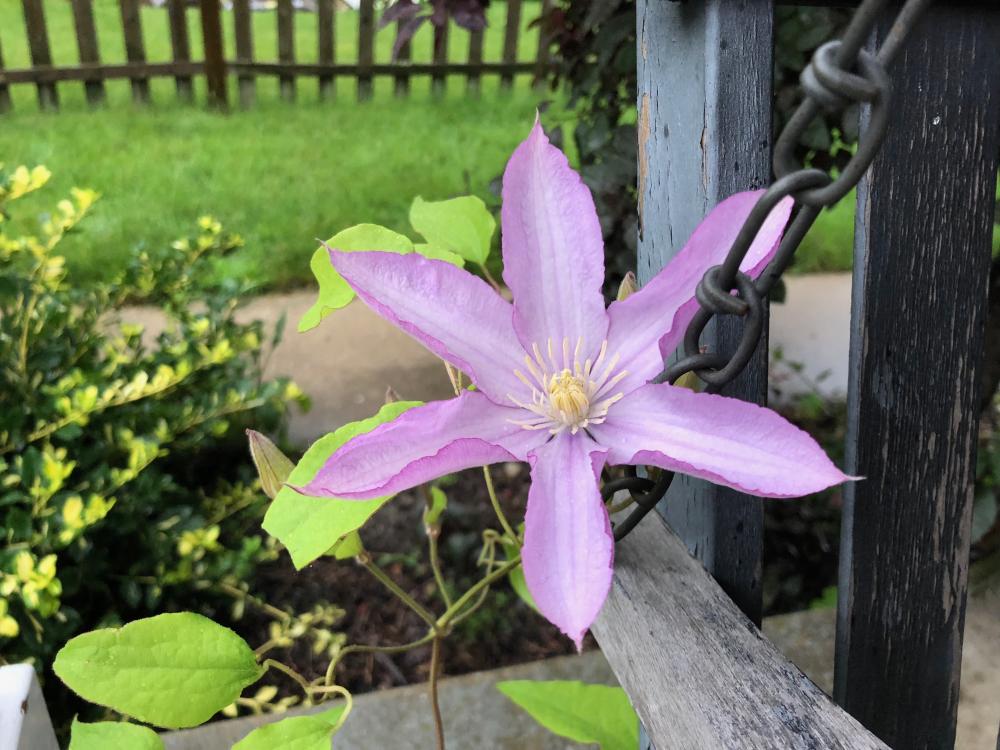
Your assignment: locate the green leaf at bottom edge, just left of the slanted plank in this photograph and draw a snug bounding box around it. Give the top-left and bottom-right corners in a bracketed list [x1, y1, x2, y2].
[497, 680, 639, 750]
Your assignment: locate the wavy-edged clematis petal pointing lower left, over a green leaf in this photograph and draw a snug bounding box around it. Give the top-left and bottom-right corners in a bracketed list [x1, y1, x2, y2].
[295, 391, 548, 499]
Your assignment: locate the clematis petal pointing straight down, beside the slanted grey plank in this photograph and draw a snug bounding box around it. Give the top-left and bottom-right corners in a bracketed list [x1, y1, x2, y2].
[521, 432, 614, 649]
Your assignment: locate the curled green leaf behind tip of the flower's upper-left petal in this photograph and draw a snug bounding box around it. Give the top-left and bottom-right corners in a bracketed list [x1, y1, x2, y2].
[299, 224, 413, 333]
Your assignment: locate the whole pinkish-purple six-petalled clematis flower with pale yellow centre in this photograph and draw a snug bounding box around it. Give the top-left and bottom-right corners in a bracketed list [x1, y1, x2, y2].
[300, 123, 846, 648]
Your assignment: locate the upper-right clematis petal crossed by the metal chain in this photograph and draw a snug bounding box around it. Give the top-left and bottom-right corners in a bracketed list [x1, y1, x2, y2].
[608, 190, 793, 392]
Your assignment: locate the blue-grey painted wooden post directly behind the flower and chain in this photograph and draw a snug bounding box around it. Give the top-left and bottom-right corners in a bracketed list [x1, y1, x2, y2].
[636, 0, 773, 623]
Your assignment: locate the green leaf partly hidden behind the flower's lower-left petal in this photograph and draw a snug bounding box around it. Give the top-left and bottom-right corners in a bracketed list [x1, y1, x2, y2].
[263, 401, 420, 569]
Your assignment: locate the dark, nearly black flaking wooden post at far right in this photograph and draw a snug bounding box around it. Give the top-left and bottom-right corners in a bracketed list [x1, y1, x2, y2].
[835, 4, 1000, 749]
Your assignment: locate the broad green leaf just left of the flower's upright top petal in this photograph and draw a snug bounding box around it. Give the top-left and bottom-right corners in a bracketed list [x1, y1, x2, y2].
[410, 195, 497, 265]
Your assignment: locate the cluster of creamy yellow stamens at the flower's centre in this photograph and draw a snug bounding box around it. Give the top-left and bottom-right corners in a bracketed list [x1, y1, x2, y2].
[507, 337, 628, 435]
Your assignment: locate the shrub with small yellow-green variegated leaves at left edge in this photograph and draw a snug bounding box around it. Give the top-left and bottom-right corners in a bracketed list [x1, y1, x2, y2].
[0, 167, 300, 664]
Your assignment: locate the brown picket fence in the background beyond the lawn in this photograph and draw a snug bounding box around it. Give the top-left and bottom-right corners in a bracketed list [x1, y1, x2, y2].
[0, 0, 552, 113]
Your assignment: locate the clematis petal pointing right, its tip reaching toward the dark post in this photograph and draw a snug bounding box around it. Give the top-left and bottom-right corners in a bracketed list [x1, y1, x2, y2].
[590, 384, 851, 497]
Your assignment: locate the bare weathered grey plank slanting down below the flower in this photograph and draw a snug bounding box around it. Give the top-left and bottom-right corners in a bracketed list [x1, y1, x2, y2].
[592, 512, 886, 750]
